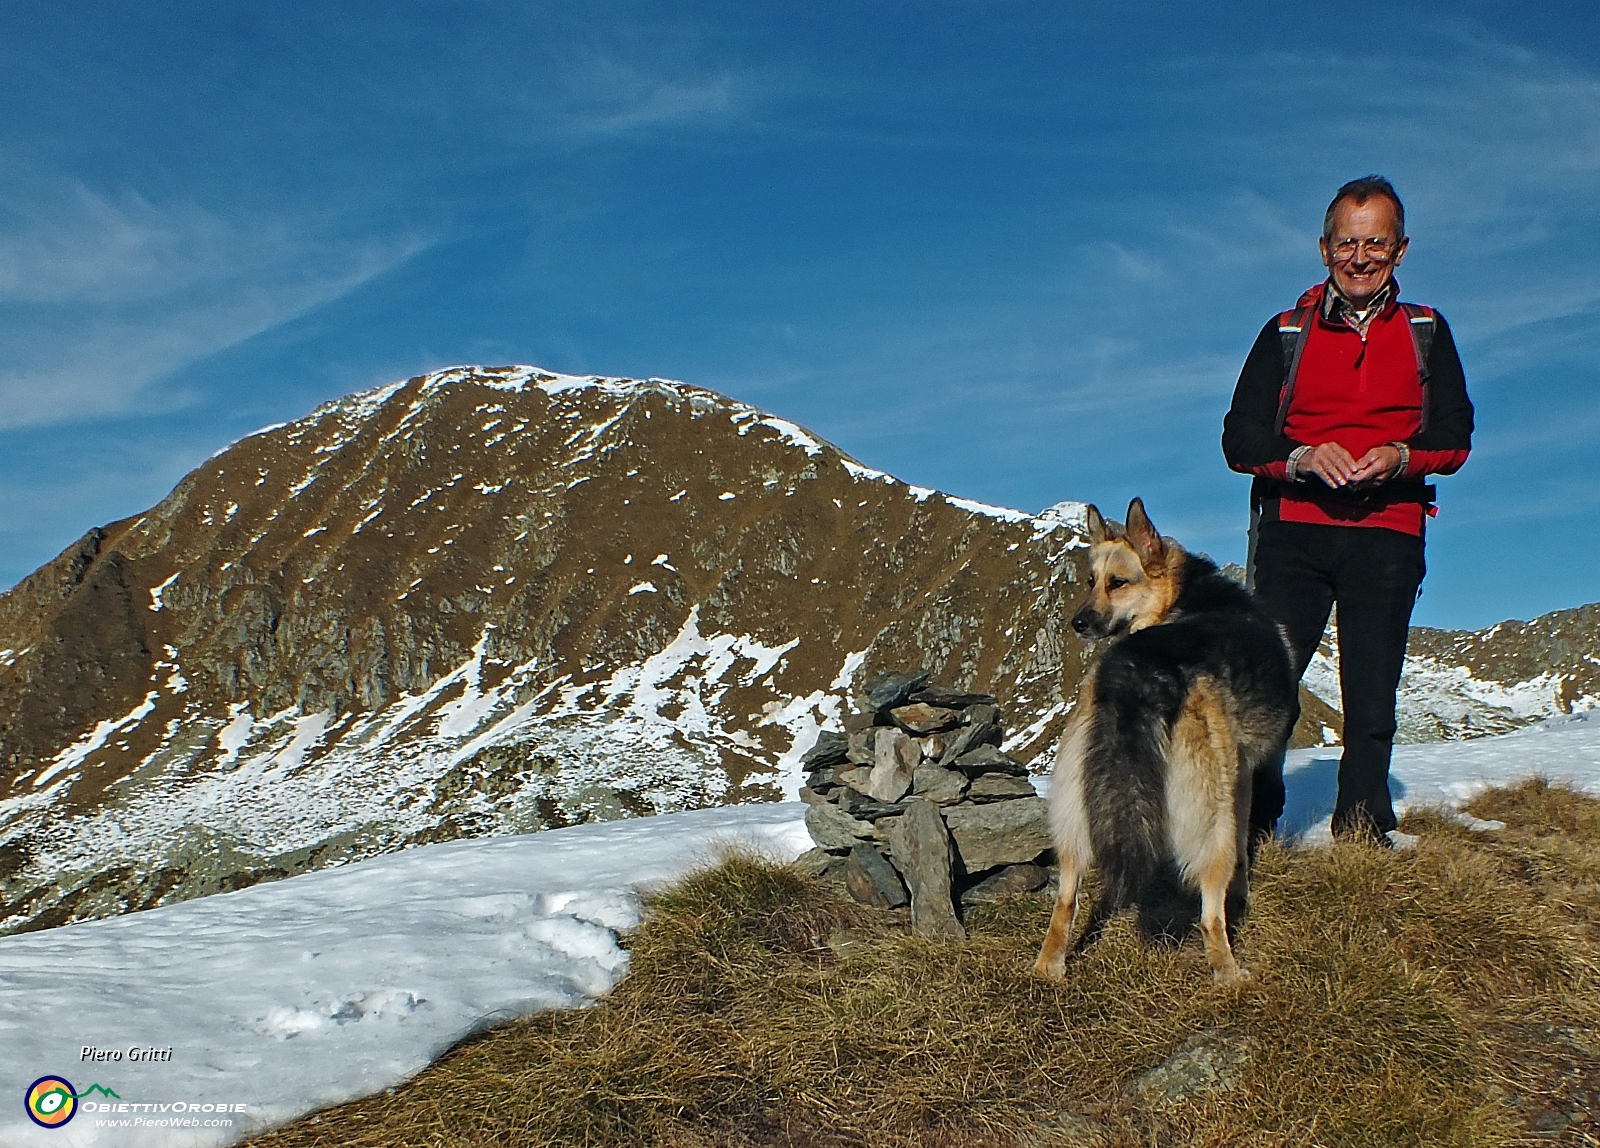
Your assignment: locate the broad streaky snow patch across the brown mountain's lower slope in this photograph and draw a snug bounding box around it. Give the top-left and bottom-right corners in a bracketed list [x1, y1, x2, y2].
[0, 606, 864, 908]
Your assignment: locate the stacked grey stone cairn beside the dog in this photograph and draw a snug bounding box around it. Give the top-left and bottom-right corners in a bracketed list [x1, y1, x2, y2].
[800, 673, 1051, 939]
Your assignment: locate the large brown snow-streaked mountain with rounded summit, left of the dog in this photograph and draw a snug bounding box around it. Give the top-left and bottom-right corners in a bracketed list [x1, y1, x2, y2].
[0, 366, 1083, 923]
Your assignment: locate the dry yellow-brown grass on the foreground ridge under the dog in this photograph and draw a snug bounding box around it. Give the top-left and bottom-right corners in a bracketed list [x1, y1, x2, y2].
[254, 783, 1600, 1148]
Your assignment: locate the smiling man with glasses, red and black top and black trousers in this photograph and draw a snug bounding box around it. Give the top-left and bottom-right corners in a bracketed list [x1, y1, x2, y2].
[1222, 176, 1472, 846]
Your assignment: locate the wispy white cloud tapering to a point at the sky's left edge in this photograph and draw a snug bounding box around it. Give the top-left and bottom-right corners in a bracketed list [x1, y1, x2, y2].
[0, 165, 426, 429]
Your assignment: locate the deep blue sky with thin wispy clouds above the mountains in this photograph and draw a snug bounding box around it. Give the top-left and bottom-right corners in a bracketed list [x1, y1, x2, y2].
[0, 0, 1600, 627]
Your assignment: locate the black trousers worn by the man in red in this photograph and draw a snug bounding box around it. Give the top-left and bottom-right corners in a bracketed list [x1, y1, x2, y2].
[1250, 521, 1427, 833]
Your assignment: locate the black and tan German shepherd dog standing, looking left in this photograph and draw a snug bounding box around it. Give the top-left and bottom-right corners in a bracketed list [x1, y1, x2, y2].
[1035, 499, 1296, 982]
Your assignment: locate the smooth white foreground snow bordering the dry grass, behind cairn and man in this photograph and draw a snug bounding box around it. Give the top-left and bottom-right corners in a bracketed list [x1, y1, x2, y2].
[0, 713, 1600, 1148]
